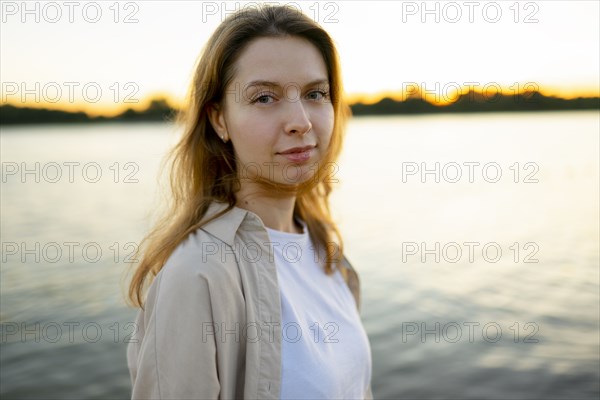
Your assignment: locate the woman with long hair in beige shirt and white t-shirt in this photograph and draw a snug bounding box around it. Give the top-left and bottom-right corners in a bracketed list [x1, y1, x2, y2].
[127, 6, 372, 399]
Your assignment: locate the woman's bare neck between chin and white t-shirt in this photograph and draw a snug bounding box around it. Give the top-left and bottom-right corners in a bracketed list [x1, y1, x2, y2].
[236, 185, 302, 233]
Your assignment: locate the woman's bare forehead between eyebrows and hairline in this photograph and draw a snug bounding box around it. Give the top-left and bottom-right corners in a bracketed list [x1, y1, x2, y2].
[233, 36, 328, 85]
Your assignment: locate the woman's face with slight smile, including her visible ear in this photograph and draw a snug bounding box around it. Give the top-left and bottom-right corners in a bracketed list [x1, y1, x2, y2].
[210, 36, 334, 184]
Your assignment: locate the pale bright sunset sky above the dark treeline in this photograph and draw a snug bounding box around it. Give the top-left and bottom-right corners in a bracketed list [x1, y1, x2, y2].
[0, 0, 600, 115]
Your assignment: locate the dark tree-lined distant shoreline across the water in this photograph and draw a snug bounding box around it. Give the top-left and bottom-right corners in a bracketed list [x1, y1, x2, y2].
[0, 92, 600, 126]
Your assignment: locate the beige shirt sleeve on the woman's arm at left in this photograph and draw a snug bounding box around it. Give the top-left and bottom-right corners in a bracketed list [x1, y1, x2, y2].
[127, 262, 220, 399]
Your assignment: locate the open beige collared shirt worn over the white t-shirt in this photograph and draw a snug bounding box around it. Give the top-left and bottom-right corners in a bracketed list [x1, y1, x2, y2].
[127, 203, 373, 399]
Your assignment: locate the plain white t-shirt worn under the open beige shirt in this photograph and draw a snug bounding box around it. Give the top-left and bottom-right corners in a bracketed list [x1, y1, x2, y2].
[267, 220, 372, 399]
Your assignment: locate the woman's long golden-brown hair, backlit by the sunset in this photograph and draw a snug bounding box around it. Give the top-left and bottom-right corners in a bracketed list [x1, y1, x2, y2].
[127, 6, 350, 308]
